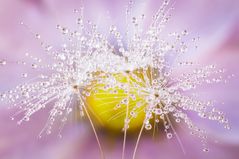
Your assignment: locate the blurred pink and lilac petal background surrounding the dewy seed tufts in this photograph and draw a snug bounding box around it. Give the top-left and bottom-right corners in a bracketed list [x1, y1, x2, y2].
[0, 0, 239, 159]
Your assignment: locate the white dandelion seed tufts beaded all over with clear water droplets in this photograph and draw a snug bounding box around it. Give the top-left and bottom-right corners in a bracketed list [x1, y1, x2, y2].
[0, 1, 229, 154]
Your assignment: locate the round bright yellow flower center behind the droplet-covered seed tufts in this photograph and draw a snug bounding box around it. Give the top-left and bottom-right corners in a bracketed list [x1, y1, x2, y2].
[85, 69, 156, 132]
